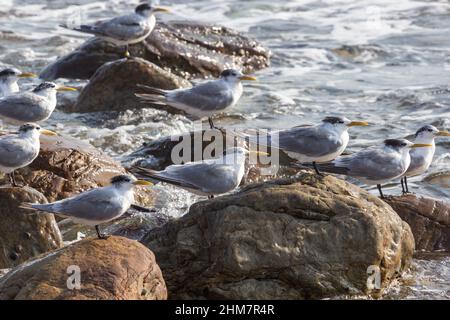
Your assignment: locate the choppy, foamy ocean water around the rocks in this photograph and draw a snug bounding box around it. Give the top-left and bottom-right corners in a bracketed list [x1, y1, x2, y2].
[0, 0, 450, 299]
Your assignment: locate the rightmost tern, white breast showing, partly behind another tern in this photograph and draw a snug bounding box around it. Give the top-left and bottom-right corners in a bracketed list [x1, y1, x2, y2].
[400, 125, 450, 194]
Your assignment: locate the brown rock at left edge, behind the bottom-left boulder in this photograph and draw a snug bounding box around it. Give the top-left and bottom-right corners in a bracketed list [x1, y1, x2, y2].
[0, 187, 62, 269]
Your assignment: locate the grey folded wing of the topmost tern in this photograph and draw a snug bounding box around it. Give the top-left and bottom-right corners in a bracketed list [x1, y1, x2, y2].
[94, 15, 151, 41]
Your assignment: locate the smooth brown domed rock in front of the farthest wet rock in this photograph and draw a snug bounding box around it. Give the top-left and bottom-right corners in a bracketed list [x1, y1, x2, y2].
[66, 58, 190, 113]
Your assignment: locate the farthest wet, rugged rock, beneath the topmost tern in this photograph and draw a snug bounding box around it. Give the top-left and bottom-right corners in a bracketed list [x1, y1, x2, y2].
[39, 21, 271, 80]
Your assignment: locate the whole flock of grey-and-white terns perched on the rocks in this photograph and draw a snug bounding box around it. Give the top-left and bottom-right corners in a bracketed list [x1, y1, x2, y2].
[0, 3, 450, 238]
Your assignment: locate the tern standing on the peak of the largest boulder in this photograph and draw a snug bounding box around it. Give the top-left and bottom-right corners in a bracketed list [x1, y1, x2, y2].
[241, 117, 369, 174]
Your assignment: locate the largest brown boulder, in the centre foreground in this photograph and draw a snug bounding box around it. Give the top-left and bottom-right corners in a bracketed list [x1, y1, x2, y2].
[142, 173, 414, 299]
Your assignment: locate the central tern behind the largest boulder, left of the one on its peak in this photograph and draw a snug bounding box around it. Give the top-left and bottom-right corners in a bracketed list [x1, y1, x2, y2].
[132, 147, 267, 198]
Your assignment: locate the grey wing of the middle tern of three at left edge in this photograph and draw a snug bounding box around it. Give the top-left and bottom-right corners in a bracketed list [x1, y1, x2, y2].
[0, 92, 45, 122]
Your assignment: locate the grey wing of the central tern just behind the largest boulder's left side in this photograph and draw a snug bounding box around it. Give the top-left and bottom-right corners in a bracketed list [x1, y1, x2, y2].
[160, 161, 235, 191]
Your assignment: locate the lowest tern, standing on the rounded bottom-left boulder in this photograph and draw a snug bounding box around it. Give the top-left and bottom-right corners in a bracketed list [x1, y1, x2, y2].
[21, 175, 152, 239]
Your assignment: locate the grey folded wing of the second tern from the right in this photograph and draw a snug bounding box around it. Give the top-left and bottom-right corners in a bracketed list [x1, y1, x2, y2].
[333, 148, 403, 180]
